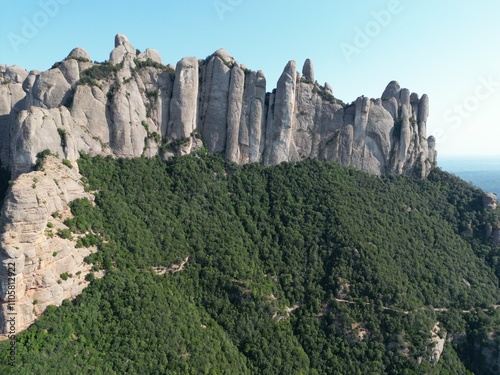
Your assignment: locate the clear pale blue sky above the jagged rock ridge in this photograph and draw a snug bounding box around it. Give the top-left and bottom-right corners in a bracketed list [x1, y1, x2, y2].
[0, 0, 500, 155]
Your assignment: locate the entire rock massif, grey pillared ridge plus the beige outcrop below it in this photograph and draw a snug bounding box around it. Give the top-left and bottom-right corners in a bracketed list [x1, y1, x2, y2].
[0, 35, 436, 336]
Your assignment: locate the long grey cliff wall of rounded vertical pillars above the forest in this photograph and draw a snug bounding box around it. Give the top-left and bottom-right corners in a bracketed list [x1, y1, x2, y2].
[0, 35, 436, 177]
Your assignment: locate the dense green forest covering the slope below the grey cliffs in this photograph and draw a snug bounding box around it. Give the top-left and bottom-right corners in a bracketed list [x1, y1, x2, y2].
[0, 154, 500, 375]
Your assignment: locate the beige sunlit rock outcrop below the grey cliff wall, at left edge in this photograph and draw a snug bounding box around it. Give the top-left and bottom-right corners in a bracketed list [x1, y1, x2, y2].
[0, 156, 93, 332]
